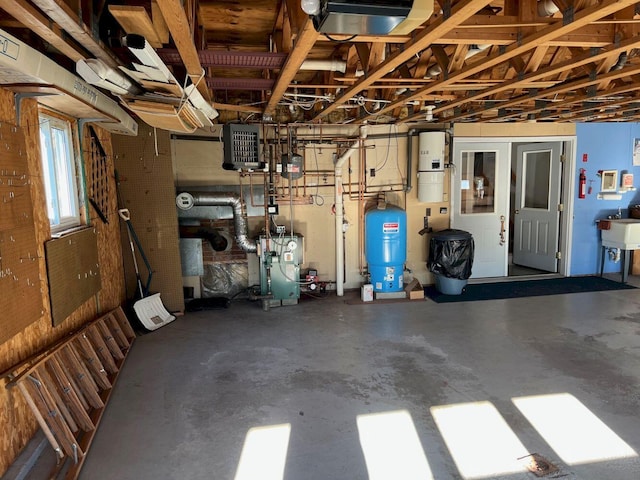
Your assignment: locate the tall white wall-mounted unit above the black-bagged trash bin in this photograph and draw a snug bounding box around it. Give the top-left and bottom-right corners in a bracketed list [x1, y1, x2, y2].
[418, 132, 445, 203]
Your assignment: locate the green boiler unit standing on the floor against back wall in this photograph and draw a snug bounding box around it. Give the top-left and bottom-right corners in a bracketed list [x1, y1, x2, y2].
[258, 234, 304, 310]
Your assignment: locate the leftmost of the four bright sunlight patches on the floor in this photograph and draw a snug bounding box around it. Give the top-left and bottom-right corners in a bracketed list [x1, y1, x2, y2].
[235, 423, 291, 480]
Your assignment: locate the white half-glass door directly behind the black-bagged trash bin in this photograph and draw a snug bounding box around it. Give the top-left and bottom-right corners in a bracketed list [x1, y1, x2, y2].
[451, 139, 510, 278]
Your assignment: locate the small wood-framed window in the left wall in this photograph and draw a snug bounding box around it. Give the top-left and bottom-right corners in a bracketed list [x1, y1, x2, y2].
[39, 112, 82, 233]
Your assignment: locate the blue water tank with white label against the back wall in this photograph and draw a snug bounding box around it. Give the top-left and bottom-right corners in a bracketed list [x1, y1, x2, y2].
[365, 205, 407, 292]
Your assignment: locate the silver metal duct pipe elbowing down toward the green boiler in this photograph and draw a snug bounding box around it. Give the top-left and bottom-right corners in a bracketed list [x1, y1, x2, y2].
[176, 192, 258, 253]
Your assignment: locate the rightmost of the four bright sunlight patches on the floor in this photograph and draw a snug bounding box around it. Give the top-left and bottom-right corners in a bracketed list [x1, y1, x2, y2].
[512, 393, 638, 465]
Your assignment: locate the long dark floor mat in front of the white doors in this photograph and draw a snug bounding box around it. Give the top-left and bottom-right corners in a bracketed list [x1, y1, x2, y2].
[424, 276, 635, 303]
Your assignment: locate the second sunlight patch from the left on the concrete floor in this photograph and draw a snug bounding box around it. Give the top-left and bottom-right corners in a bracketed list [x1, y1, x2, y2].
[357, 410, 433, 480]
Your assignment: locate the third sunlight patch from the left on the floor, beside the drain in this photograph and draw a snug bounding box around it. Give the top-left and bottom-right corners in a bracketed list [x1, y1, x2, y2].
[431, 402, 530, 480]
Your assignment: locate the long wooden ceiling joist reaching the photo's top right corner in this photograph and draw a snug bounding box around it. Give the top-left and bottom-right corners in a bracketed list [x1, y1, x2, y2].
[388, 0, 635, 122]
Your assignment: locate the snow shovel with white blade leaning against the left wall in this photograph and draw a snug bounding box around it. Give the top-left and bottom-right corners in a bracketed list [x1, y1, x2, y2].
[118, 208, 176, 331]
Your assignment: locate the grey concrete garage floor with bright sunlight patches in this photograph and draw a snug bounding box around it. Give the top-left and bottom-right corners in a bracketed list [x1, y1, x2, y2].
[80, 282, 640, 480]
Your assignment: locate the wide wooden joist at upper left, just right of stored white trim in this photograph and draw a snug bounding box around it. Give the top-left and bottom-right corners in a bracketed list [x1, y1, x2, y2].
[157, 0, 211, 102]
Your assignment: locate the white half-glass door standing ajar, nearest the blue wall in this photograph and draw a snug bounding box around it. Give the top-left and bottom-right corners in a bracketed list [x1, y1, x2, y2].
[513, 142, 561, 273]
